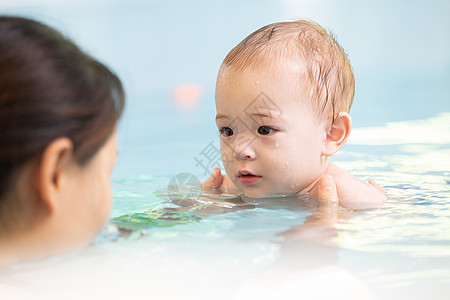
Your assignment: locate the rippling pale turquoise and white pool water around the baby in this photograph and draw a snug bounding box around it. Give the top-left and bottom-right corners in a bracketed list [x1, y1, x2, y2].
[1, 113, 450, 299]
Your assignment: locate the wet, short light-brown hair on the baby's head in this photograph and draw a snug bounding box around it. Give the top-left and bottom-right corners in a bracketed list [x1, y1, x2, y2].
[222, 20, 355, 120]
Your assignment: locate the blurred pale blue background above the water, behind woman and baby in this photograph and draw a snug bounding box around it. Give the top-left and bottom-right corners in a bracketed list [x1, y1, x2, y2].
[0, 0, 450, 179]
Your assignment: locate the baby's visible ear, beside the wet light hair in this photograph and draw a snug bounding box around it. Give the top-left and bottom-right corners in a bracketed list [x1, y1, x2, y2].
[322, 112, 352, 156]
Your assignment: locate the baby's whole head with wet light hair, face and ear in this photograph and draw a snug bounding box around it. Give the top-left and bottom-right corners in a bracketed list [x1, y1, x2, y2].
[216, 21, 354, 196]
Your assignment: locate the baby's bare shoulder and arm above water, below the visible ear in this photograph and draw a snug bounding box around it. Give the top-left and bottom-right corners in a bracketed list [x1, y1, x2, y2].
[326, 163, 386, 209]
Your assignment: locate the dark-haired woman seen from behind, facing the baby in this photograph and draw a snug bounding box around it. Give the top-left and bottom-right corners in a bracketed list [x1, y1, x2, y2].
[0, 17, 125, 264]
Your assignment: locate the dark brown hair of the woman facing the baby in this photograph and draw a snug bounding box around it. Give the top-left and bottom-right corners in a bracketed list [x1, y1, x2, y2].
[0, 16, 125, 202]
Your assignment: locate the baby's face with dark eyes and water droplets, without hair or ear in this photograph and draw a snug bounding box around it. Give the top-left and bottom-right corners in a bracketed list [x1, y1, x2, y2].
[216, 65, 326, 196]
